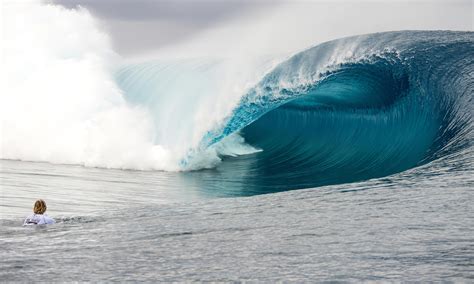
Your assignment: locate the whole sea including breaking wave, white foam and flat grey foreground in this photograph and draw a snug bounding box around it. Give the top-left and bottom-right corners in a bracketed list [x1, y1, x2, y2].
[0, 2, 474, 281]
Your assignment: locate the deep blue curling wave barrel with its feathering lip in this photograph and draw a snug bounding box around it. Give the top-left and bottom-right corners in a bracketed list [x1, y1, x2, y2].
[191, 31, 474, 193]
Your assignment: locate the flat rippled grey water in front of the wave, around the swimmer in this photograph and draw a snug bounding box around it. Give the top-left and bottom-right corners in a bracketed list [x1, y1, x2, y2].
[0, 148, 474, 282]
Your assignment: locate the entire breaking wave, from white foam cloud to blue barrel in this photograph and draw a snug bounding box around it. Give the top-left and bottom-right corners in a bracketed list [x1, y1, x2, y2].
[1, 0, 474, 192]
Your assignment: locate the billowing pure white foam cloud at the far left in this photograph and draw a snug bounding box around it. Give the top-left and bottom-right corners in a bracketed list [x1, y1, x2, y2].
[0, 2, 178, 170]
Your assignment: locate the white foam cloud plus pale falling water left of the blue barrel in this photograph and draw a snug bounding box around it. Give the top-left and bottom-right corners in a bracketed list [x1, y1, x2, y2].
[0, 2, 275, 171]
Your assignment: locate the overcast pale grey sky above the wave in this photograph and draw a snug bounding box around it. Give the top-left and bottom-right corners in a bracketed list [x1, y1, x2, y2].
[52, 0, 474, 56]
